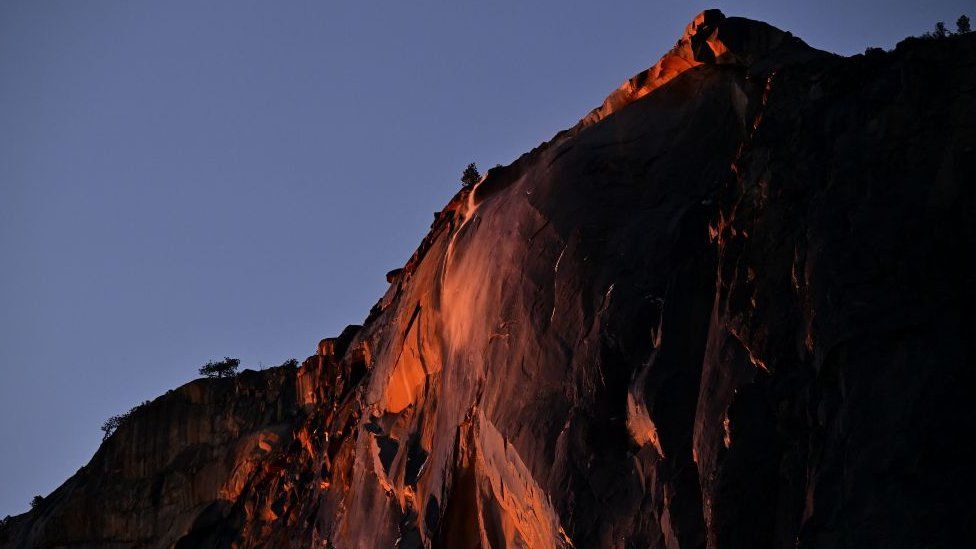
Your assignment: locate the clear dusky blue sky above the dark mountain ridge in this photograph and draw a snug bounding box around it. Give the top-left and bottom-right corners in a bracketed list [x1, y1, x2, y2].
[0, 0, 976, 516]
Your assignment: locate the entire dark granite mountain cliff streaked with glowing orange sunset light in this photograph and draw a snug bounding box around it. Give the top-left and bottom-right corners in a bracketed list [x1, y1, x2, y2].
[3, 10, 976, 548]
